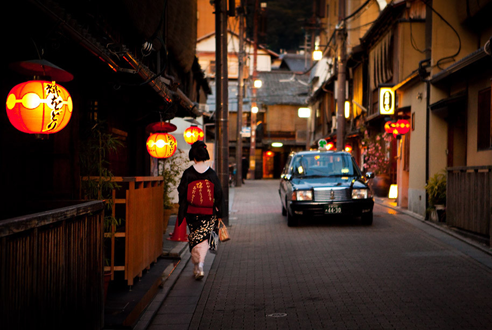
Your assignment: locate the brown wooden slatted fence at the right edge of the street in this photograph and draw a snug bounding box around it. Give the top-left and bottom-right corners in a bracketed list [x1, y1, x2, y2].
[446, 166, 492, 244]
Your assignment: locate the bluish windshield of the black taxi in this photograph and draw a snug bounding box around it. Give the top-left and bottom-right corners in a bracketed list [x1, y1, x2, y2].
[292, 153, 359, 178]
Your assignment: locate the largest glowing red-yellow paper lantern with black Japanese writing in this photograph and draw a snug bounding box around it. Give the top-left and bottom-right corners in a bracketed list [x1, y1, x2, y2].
[6, 80, 73, 134]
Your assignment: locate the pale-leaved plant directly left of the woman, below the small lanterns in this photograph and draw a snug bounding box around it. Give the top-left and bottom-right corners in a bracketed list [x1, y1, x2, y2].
[159, 149, 191, 233]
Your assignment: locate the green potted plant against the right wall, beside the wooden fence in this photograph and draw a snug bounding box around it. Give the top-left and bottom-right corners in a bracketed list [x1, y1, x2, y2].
[425, 170, 446, 221]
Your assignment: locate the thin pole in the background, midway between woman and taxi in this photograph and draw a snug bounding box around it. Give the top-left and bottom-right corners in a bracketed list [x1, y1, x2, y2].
[249, 0, 260, 180]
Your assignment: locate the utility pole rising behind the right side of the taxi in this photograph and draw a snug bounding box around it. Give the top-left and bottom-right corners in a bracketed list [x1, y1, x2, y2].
[336, 0, 347, 151]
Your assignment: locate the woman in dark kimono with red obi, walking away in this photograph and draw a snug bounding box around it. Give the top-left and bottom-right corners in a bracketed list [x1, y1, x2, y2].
[178, 141, 223, 280]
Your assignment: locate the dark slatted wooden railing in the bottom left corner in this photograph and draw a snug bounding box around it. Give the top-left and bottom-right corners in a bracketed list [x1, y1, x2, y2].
[0, 201, 104, 329]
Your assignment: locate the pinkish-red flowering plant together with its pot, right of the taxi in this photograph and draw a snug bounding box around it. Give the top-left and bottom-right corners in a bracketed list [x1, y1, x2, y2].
[362, 129, 391, 197]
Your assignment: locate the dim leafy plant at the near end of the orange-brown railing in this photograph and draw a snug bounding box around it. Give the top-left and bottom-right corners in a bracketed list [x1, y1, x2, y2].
[79, 122, 123, 232]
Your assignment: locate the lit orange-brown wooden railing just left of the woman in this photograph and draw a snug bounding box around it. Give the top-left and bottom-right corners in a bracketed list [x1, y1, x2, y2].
[99, 176, 164, 285]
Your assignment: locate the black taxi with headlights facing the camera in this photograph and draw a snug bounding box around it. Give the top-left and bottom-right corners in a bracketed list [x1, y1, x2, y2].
[279, 151, 374, 226]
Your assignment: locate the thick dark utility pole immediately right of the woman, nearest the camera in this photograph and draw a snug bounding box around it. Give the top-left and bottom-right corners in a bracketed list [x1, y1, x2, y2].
[215, 0, 229, 226]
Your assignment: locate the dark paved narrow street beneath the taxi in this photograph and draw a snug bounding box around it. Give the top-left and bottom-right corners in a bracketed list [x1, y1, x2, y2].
[149, 180, 492, 329]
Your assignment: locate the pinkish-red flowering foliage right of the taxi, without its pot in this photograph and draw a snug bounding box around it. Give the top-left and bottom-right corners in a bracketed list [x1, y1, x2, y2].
[362, 130, 391, 175]
